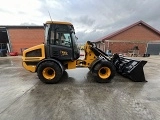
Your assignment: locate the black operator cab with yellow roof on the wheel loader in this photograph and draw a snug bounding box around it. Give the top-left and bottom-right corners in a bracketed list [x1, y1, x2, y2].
[45, 21, 80, 61]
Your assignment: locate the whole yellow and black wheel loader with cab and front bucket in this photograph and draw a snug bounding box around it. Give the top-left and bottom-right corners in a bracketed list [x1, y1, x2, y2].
[22, 21, 147, 83]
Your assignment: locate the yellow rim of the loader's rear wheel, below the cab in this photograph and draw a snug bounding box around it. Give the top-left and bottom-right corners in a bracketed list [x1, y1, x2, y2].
[42, 67, 56, 80]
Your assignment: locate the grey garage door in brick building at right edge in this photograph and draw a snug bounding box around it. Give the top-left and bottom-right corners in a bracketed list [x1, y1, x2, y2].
[147, 43, 160, 55]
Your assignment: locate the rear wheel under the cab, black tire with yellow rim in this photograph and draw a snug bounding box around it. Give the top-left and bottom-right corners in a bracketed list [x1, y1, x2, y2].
[37, 61, 62, 84]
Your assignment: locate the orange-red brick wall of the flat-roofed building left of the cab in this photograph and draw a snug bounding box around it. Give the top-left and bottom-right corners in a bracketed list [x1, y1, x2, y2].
[8, 28, 44, 54]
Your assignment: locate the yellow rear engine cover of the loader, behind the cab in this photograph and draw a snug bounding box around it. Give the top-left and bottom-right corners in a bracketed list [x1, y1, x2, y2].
[22, 44, 45, 72]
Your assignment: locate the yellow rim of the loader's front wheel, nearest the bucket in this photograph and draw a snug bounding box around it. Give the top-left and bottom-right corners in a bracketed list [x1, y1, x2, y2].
[98, 67, 111, 79]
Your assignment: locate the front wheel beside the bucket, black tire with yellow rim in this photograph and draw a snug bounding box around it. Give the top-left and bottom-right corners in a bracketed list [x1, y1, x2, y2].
[93, 61, 116, 83]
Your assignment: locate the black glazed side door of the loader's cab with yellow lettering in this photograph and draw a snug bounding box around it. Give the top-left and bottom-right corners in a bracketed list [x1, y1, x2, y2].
[49, 31, 73, 61]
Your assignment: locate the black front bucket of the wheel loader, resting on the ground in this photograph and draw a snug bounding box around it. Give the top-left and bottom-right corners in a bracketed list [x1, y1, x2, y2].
[112, 54, 147, 82]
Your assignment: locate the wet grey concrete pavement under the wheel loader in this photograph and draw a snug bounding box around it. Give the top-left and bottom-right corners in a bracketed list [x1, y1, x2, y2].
[0, 56, 160, 120]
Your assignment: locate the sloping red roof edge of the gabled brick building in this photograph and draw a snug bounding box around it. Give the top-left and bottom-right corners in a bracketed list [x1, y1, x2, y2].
[96, 20, 160, 42]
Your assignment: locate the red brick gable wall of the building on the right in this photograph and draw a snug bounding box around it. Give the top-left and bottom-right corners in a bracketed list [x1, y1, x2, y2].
[105, 25, 160, 55]
